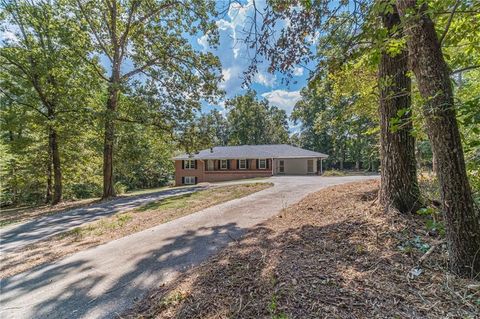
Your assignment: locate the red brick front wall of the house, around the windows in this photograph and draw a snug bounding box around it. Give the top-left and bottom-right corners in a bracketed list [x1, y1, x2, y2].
[175, 159, 272, 186]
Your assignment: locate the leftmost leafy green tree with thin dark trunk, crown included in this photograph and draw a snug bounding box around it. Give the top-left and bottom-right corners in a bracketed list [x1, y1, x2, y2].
[0, 1, 98, 204]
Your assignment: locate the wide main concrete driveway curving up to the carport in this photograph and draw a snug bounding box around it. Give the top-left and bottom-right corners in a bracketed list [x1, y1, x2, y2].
[0, 176, 372, 319]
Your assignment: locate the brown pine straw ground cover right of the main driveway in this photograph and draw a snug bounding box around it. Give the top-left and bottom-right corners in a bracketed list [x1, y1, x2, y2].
[124, 181, 480, 319]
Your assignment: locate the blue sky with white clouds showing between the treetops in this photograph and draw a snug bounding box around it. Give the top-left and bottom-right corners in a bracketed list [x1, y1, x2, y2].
[195, 0, 308, 116]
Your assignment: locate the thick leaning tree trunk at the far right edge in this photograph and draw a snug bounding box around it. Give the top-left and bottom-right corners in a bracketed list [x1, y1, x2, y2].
[397, 0, 480, 276]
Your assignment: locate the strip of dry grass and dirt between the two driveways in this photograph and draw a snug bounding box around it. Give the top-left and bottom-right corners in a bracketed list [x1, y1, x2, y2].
[0, 183, 273, 278]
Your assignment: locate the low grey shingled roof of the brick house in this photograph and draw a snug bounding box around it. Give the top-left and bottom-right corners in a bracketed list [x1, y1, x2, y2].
[173, 144, 328, 160]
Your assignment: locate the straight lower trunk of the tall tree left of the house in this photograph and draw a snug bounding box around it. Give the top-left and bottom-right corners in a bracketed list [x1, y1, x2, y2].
[102, 83, 118, 199]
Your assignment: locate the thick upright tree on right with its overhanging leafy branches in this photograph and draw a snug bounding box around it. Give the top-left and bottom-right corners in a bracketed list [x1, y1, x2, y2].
[242, 0, 420, 212]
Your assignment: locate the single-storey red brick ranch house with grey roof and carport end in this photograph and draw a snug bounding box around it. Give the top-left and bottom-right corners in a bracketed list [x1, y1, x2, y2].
[173, 144, 328, 185]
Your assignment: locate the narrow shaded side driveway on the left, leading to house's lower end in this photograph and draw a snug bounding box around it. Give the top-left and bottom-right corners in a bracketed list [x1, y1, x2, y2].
[0, 186, 207, 252]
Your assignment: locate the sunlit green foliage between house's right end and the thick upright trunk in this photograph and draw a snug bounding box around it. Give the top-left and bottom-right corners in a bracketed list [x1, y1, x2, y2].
[292, 69, 379, 171]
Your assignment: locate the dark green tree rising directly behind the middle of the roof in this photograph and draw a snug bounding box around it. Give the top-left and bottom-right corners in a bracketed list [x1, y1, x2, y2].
[225, 91, 288, 145]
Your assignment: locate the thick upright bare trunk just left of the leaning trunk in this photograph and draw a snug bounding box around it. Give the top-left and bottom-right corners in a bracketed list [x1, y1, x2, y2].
[378, 3, 421, 213]
